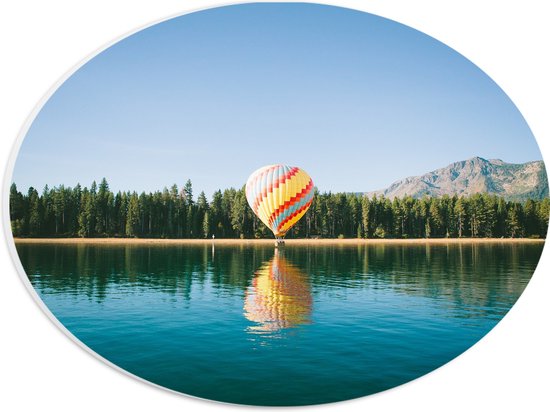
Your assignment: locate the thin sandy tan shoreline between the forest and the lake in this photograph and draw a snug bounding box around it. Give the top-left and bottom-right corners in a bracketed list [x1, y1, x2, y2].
[13, 238, 546, 246]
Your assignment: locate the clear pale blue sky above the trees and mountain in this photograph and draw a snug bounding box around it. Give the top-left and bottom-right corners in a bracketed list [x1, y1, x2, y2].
[13, 3, 542, 197]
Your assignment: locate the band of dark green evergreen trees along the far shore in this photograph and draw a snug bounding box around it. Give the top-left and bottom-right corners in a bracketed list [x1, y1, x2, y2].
[10, 179, 550, 238]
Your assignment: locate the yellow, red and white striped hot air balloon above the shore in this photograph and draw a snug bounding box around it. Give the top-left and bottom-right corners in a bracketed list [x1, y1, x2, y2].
[246, 165, 313, 238]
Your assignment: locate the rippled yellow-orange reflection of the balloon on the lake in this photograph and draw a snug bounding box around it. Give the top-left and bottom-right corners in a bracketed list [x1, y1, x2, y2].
[244, 250, 312, 333]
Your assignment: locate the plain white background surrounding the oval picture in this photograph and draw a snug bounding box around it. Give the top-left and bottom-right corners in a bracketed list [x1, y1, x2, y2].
[0, 0, 550, 411]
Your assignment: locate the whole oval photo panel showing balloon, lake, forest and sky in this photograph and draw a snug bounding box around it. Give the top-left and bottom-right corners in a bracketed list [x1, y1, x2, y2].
[9, 3, 550, 406]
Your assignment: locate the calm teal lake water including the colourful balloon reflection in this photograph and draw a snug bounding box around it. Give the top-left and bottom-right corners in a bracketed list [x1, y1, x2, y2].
[16, 242, 543, 405]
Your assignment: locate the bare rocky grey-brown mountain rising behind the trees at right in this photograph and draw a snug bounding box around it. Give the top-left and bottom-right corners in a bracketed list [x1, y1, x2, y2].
[367, 157, 548, 201]
